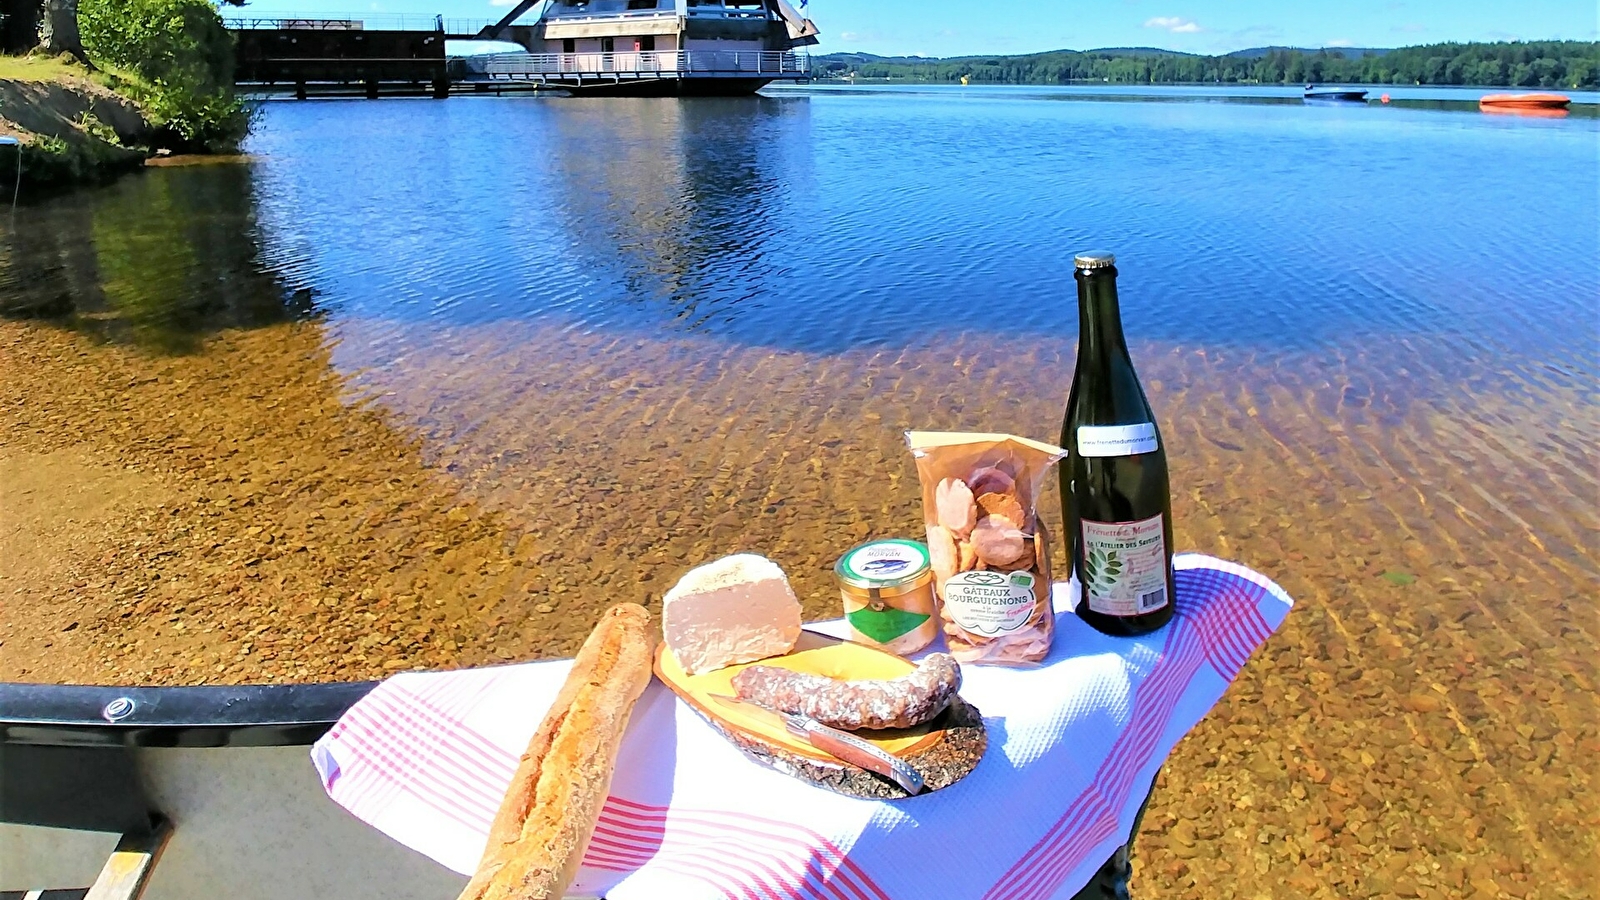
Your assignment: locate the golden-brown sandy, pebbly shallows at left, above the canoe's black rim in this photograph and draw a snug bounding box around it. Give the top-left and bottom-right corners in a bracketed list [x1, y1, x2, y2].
[0, 317, 590, 684]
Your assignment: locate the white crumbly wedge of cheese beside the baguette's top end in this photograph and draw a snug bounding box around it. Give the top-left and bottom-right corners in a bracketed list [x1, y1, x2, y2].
[661, 552, 800, 674]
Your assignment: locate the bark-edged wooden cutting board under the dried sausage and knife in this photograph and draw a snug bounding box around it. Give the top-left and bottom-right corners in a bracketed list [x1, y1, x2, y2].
[654, 631, 987, 799]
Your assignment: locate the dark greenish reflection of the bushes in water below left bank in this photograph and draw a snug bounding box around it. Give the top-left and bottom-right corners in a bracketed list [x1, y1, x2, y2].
[0, 165, 315, 354]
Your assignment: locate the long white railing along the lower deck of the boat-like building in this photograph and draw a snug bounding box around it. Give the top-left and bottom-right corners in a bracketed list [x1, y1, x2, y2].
[482, 50, 811, 80]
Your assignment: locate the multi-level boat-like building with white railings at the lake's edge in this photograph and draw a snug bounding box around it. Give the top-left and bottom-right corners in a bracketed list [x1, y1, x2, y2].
[469, 0, 818, 96]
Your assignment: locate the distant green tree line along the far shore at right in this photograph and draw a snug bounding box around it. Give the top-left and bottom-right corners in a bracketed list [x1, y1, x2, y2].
[811, 40, 1600, 90]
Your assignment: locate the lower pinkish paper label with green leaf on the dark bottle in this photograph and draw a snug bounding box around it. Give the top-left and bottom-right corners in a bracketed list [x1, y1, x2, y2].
[1083, 514, 1171, 615]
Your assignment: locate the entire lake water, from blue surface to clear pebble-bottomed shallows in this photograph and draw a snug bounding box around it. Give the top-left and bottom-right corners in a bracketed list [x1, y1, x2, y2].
[0, 88, 1600, 898]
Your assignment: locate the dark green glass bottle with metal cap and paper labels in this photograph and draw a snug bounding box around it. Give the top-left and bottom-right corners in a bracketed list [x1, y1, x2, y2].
[1061, 251, 1176, 636]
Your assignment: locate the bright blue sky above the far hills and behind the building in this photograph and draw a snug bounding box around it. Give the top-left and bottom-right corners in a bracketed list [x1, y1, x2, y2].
[236, 0, 1600, 56]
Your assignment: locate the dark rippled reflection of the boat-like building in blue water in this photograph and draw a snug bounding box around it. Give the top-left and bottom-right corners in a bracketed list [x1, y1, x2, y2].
[547, 96, 811, 330]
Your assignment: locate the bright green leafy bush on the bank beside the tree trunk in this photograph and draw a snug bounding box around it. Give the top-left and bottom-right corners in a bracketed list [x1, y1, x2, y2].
[78, 0, 250, 151]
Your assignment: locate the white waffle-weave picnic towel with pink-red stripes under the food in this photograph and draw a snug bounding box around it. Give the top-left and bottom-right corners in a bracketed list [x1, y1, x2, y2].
[312, 554, 1291, 900]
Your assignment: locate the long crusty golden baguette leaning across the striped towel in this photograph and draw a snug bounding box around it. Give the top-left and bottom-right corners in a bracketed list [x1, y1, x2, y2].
[459, 604, 651, 900]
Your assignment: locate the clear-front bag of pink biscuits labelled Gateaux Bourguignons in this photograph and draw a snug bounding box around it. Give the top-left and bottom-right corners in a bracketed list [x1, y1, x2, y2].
[906, 431, 1067, 666]
